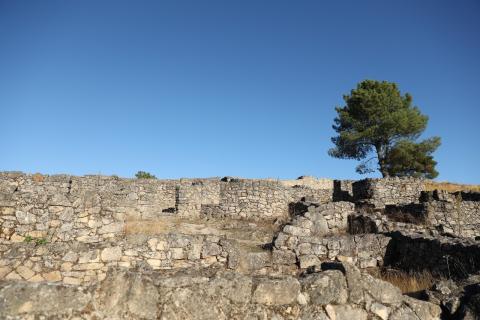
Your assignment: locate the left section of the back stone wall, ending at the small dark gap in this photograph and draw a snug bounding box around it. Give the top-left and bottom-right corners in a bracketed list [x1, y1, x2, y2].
[0, 173, 175, 243]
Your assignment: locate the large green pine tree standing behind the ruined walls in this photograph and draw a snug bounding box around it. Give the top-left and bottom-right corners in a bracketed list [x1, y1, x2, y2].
[329, 80, 440, 177]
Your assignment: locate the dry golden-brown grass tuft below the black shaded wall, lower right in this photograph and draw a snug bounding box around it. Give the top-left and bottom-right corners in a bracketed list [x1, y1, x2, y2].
[373, 269, 436, 294]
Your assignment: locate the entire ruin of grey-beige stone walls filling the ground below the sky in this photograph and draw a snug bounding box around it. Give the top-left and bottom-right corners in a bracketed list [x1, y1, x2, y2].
[0, 172, 480, 320]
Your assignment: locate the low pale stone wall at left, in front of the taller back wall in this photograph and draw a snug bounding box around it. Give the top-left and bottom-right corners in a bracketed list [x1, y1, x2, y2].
[0, 233, 231, 284]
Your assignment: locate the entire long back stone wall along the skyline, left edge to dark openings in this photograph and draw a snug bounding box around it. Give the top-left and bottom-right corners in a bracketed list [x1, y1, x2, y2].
[0, 173, 332, 243]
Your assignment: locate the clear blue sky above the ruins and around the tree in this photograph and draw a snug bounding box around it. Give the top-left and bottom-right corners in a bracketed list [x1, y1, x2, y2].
[0, 0, 480, 183]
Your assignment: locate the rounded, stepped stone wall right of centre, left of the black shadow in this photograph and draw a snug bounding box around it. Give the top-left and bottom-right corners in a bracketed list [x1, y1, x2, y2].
[273, 202, 390, 269]
